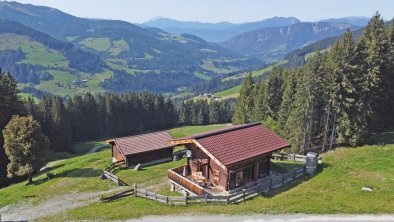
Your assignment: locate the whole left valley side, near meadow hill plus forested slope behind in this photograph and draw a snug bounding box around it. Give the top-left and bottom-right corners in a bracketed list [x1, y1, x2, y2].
[0, 2, 263, 96]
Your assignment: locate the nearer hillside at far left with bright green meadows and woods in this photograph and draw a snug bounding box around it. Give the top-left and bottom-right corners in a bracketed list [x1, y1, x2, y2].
[0, 20, 112, 97]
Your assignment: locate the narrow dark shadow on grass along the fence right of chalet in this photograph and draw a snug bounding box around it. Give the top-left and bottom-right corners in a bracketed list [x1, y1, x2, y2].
[260, 163, 331, 198]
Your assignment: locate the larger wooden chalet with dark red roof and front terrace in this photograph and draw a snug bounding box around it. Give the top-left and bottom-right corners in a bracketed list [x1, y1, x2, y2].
[168, 123, 290, 195]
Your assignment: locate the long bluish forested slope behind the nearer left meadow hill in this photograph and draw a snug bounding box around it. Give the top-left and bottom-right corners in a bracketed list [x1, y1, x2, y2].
[0, 2, 262, 93]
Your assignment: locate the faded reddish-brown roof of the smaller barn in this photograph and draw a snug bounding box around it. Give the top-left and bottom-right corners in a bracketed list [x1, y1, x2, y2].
[113, 131, 172, 156]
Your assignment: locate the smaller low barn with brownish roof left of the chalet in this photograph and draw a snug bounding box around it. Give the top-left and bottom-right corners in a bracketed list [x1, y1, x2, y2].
[107, 131, 174, 167]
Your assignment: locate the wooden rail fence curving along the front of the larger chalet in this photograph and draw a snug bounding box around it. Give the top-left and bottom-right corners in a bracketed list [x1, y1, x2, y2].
[133, 168, 305, 205]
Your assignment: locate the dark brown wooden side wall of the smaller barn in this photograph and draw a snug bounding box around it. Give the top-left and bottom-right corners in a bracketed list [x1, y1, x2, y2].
[127, 147, 173, 166]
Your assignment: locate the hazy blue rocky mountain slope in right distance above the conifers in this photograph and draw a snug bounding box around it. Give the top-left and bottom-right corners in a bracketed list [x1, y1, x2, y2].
[221, 22, 358, 63]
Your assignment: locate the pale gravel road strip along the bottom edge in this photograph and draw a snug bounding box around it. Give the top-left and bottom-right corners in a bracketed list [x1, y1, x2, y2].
[130, 214, 394, 222]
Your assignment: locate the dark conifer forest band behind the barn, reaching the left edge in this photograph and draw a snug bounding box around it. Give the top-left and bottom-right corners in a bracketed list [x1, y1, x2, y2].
[0, 72, 232, 187]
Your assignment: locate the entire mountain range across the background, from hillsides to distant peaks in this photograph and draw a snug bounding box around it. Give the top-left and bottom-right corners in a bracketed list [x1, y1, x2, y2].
[0, 1, 372, 97]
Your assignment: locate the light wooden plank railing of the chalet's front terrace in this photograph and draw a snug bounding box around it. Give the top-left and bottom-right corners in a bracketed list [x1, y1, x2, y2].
[168, 165, 205, 195]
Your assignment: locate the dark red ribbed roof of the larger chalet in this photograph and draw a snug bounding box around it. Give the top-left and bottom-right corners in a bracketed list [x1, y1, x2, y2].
[181, 123, 290, 166]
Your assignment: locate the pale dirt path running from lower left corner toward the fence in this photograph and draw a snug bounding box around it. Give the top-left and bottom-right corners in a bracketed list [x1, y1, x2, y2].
[0, 187, 126, 221]
